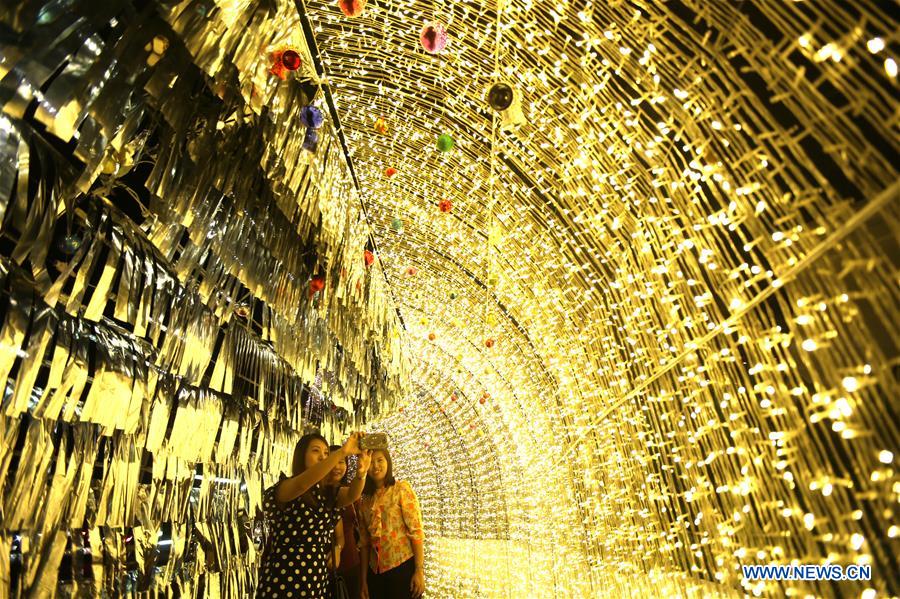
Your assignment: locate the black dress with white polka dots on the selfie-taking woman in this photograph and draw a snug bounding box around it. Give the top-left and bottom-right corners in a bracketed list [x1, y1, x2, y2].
[256, 485, 340, 599]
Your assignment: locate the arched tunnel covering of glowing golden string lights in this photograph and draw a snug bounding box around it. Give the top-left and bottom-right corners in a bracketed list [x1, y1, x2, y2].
[301, 0, 900, 596]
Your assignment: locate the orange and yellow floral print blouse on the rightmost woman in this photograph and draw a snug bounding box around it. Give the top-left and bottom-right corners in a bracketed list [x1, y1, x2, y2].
[359, 480, 425, 574]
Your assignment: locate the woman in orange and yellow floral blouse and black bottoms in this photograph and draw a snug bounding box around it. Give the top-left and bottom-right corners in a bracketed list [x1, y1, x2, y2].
[359, 449, 425, 599]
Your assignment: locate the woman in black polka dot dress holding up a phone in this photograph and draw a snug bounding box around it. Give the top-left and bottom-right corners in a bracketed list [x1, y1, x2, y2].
[256, 433, 371, 599]
